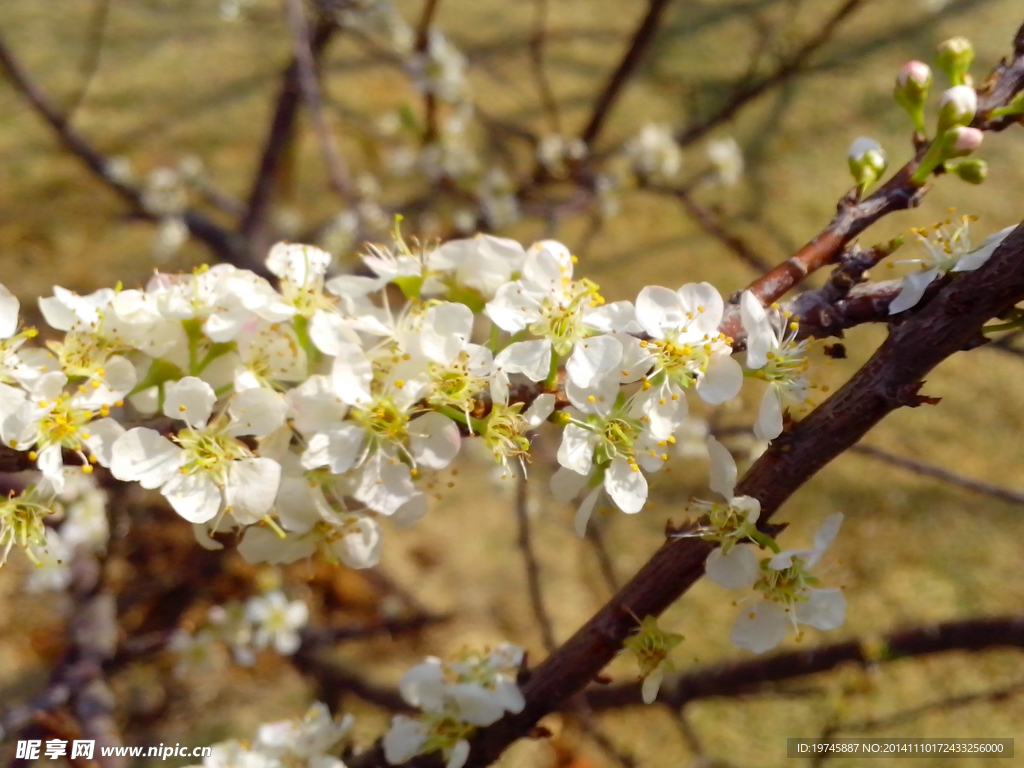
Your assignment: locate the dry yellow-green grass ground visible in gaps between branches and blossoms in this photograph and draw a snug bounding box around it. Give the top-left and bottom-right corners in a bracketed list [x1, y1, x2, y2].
[0, 0, 1024, 768]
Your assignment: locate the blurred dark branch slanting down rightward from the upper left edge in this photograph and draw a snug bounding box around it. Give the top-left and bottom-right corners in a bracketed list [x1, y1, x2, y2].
[0, 31, 254, 274]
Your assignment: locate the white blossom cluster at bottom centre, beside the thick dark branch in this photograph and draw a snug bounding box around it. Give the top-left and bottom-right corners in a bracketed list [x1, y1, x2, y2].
[384, 643, 525, 768]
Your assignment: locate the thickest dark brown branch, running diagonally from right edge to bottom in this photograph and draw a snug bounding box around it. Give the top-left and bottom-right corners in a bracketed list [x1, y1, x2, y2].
[385, 215, 1024, 767]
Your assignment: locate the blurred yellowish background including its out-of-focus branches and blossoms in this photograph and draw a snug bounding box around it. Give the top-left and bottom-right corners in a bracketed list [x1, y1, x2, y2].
[0, 0, 1024, 768]
